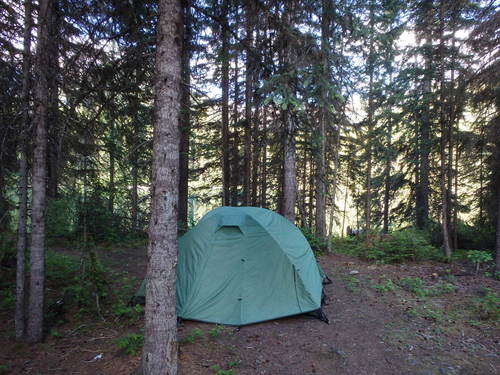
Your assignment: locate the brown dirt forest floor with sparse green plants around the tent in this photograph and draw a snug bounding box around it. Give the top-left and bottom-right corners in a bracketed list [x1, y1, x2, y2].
[0, 242, 500, 375]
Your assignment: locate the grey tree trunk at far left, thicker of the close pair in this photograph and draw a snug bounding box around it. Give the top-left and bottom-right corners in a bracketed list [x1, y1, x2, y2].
[27, 0, 53, 342]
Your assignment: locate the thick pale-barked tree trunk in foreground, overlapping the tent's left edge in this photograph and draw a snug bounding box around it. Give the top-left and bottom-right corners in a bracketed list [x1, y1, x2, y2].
[142, 0, 183, 375]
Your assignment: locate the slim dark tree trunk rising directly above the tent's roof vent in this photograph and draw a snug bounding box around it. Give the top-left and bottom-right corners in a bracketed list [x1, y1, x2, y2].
[221, 0, 231, 206]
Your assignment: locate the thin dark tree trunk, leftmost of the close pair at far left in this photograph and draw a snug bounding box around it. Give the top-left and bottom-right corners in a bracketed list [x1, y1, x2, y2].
[15, 0, 33, 340]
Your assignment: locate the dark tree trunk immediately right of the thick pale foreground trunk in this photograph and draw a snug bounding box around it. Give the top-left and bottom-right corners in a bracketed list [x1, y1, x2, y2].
[178, 0, 192, 230]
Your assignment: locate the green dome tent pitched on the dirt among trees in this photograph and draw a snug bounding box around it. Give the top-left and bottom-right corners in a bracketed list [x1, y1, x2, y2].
[136, 207, 326, 325]
